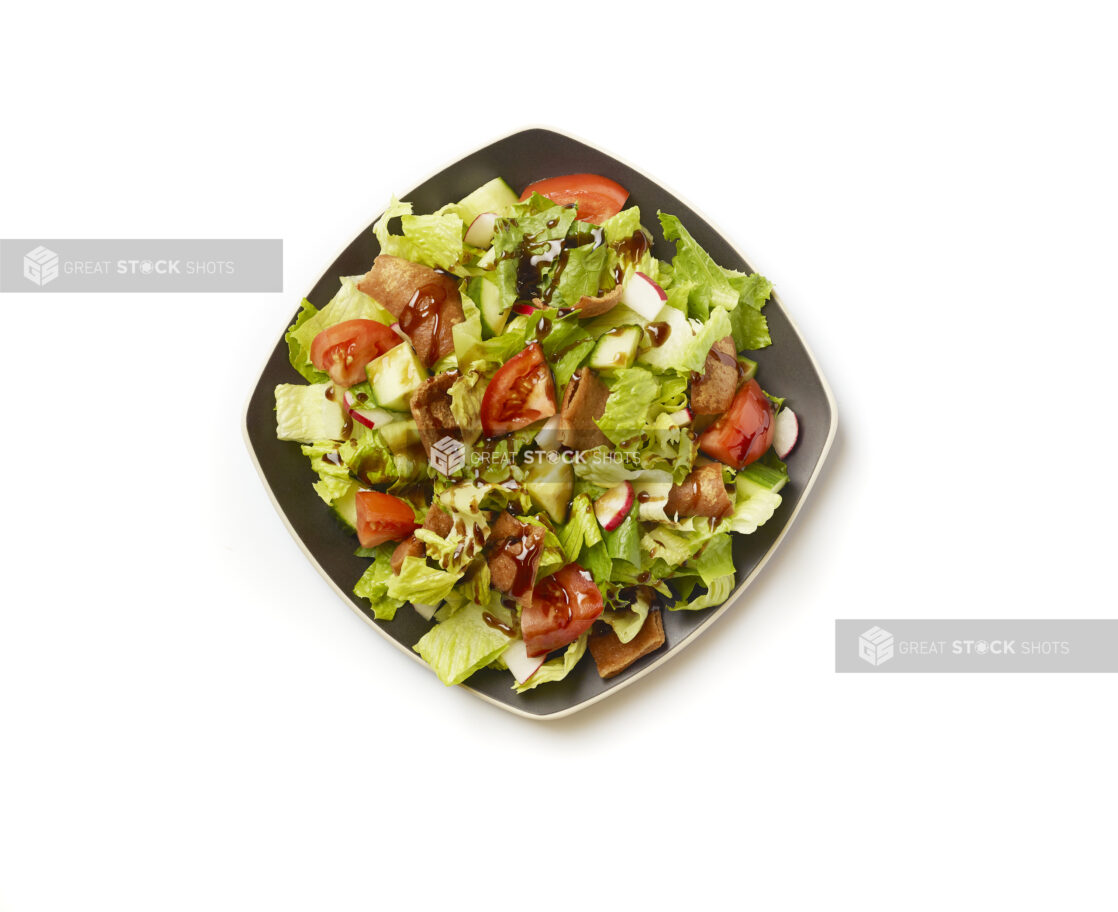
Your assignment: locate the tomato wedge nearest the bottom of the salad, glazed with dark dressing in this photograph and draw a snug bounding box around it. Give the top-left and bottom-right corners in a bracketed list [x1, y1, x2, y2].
[520, 563, 605, 656]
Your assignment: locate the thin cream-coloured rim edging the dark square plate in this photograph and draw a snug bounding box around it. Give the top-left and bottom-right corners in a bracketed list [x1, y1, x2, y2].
[240, 124, 839, 722]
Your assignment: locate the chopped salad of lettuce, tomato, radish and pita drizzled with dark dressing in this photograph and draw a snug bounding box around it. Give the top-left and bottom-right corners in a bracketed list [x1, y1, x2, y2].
[275, 174, 798, 692]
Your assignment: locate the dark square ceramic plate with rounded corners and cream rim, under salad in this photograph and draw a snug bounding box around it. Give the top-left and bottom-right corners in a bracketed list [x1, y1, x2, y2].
[245, 129, 836, 719]
